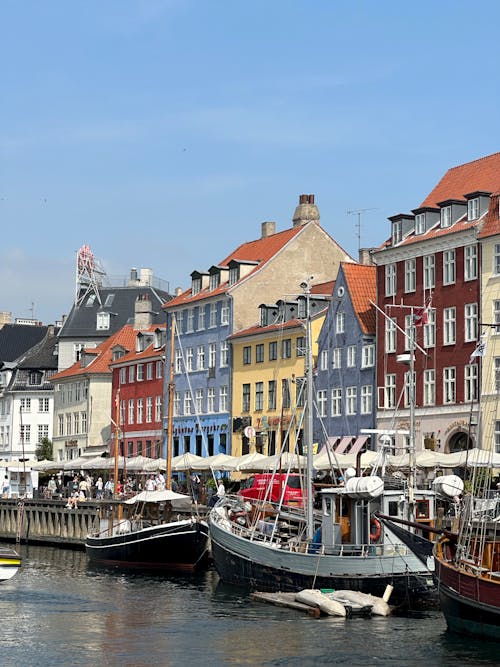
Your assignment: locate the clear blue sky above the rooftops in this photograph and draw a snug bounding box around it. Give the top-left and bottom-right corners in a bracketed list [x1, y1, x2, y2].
[0, 0, 500, 323]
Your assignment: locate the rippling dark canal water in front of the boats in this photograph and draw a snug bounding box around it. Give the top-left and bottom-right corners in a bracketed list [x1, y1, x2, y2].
[0, 545, 498, 667]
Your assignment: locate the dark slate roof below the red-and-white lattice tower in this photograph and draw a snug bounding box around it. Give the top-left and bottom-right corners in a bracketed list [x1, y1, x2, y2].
[59, 286, 172, 340]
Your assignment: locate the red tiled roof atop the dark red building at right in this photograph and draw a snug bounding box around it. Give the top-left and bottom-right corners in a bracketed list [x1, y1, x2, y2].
[420, 153, 500, 208]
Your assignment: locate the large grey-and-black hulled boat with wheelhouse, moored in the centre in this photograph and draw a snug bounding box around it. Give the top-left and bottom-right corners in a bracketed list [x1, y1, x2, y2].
[210, 287, 435, 605]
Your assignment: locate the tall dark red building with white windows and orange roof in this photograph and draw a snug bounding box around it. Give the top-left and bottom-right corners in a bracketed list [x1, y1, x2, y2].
[373, 153, 500, 452]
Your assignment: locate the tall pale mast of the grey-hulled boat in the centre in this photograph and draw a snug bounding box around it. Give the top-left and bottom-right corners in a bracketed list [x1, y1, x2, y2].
[300, 281, 314, 540]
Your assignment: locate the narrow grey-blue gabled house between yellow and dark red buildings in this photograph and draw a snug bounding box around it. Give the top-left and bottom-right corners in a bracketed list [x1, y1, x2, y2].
[313, 263, 376, 445]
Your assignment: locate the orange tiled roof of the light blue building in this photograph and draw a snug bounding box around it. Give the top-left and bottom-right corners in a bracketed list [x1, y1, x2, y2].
[163, 225, 305, 310]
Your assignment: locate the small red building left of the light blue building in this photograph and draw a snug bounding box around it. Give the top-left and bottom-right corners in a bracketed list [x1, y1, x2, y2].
[110, 326, 165, 458]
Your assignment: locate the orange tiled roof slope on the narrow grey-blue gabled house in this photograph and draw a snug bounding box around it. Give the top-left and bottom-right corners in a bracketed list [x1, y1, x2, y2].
[341, 262, 377, 334]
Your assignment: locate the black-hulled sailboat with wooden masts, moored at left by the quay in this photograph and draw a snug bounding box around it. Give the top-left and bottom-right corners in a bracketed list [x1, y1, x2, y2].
[85, 317, 209, 572]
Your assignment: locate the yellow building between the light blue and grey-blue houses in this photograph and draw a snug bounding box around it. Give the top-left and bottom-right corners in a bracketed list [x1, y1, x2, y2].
[229, 290, 333, 456]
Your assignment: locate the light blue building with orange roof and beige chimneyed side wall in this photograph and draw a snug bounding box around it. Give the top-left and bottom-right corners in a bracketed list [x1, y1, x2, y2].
[164, 190, 351, 455]
